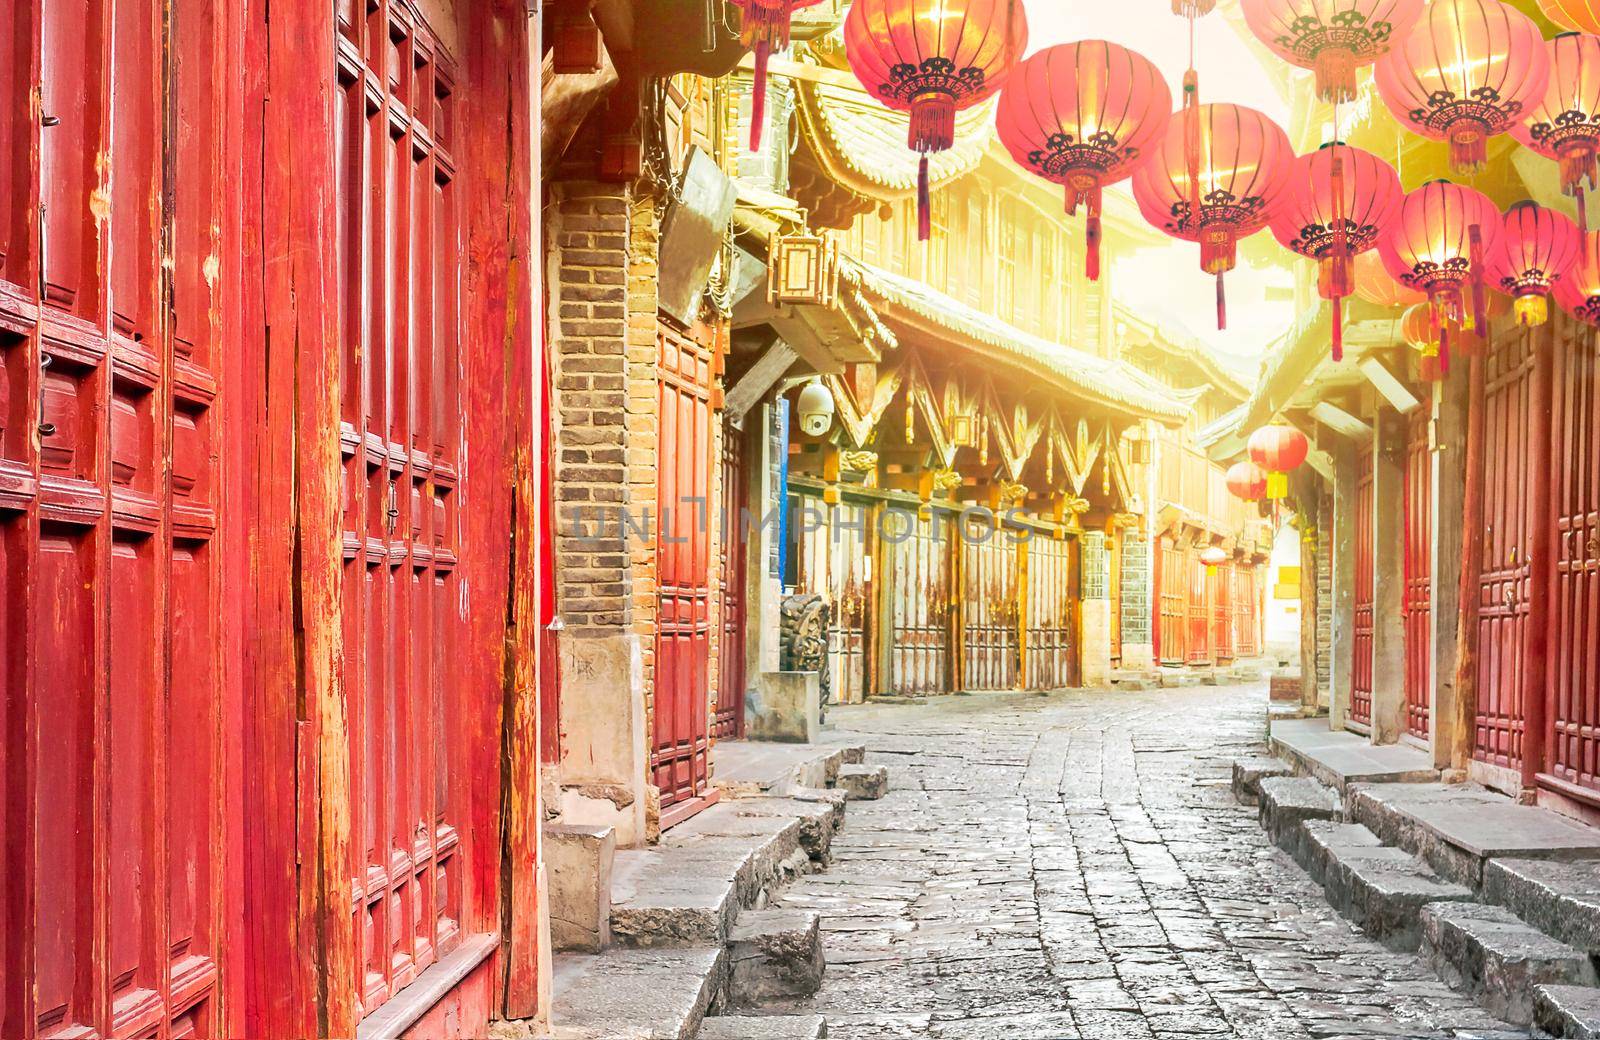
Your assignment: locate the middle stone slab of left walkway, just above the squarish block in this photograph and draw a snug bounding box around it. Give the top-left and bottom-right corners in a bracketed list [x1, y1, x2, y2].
[611, 802, 810, 947]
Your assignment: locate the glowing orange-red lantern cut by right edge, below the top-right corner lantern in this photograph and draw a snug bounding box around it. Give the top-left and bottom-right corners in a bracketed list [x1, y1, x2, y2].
[1510, 33, 1600, 230]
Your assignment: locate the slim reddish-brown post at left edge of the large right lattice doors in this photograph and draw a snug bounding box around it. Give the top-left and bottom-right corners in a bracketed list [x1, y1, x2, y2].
[1452, 354, 1485, 773]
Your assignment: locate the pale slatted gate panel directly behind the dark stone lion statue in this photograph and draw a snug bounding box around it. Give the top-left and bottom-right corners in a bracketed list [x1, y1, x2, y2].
[795, 494, 874, 704]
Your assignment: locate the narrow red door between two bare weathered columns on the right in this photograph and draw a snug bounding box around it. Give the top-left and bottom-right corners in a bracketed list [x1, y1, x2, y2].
[1402, 408, 1434, 738]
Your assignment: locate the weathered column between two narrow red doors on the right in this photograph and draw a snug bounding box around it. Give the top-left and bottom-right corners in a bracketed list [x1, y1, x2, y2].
[1371, 408, 1408, 744]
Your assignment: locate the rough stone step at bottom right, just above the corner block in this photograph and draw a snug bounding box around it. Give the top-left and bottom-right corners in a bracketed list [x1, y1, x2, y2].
[1421, 902, 1595, 1026]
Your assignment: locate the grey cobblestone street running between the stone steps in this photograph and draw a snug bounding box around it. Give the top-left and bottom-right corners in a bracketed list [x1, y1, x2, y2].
[771, 686, 1526, 1040]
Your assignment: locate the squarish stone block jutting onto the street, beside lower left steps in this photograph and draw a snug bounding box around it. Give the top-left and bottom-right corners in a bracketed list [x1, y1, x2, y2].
[728, 910, 826, 1008]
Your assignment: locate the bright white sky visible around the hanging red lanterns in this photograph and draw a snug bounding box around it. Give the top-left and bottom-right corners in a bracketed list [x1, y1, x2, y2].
[1024, 0, 1309, 358]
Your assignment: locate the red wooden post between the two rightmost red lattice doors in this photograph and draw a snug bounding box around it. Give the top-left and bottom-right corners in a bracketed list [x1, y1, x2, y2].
[1522, 317, 1560, 798]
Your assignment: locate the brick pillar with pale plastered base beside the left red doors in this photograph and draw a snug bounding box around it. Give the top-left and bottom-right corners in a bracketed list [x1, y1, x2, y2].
[549, 181, 654, 845]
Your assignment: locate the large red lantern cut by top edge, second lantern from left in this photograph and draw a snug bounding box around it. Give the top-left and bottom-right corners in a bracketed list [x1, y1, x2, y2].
[845, 0, 1027, 242]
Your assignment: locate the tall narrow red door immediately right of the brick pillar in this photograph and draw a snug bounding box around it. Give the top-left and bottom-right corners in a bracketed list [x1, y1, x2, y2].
[650, 325, 712, 808]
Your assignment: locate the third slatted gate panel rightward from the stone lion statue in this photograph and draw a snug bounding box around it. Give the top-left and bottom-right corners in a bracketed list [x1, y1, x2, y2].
[962, 515, 1021, 690]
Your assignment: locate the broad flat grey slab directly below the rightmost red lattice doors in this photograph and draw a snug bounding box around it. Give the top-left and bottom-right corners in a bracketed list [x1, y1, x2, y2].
[1347, 782, 1600, 888]
